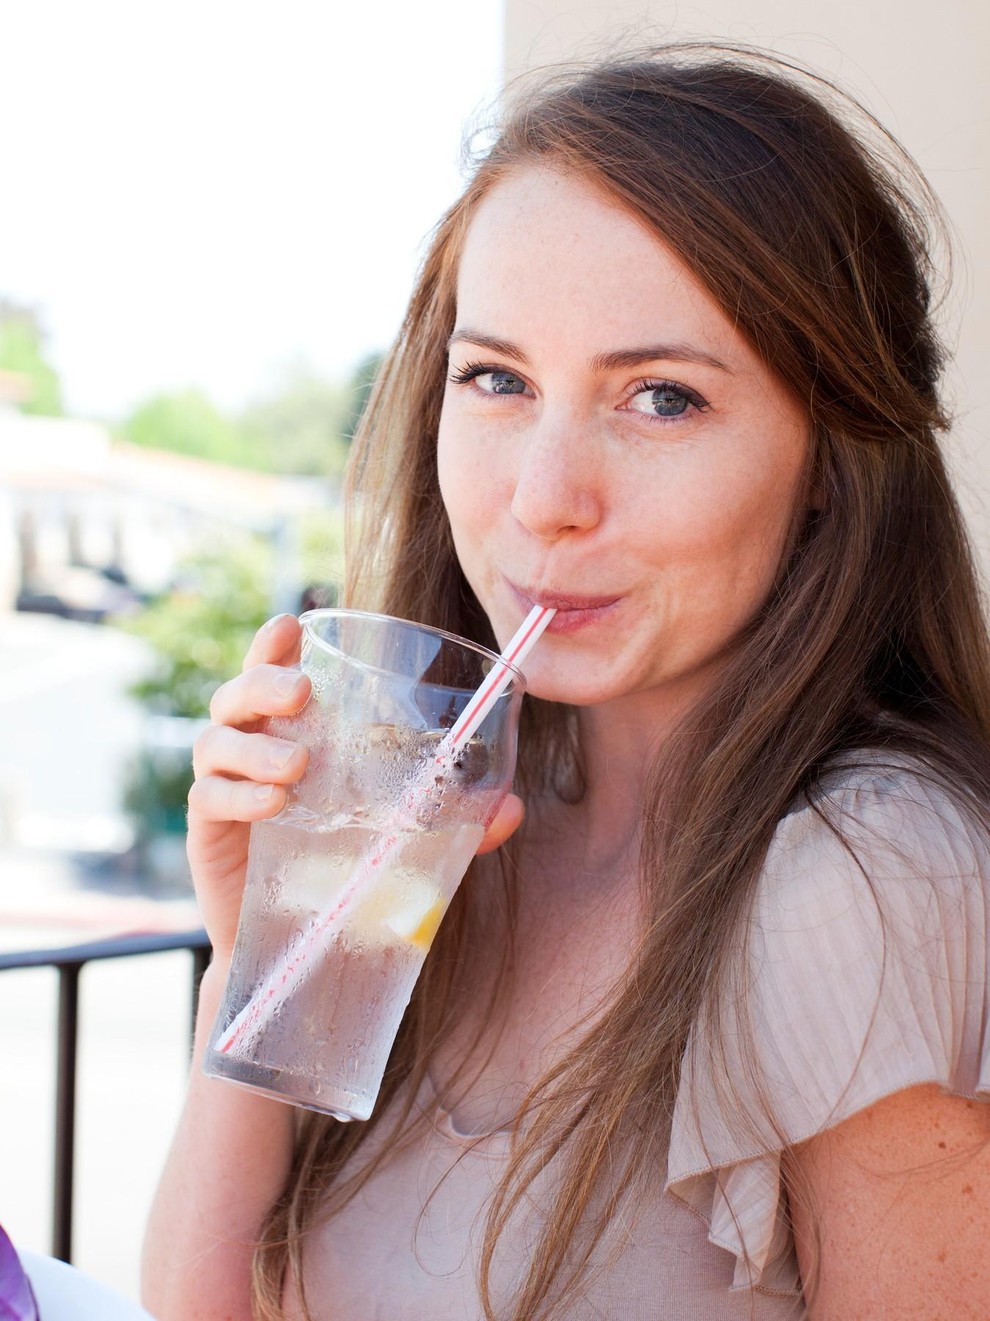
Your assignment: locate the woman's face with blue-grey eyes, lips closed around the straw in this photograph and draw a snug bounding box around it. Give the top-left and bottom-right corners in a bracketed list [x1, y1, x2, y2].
[439, 168, 810, 704]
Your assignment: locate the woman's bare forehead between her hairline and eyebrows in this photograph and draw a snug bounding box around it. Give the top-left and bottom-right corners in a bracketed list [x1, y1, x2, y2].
[457, 166, 747, 351]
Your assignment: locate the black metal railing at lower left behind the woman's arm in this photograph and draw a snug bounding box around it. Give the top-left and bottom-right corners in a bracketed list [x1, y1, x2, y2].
[0, 930, 210, 1262]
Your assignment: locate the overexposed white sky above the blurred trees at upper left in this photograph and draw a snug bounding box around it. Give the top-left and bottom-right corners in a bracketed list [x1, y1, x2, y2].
[0, 0, 502, 417]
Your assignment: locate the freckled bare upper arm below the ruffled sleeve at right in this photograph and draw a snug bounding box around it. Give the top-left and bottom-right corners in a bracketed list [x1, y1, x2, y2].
[786, 1085, 990, 1321]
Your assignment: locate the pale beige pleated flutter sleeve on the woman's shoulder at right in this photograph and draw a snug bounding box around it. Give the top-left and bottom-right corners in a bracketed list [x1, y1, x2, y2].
[667, 766, 990, 1292]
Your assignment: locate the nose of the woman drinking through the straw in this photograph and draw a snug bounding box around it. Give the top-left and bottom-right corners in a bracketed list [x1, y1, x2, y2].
[510, 411, 604, 542]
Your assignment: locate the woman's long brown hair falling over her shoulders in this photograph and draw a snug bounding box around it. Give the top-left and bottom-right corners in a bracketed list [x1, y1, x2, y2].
[255, 45, 990, 1321]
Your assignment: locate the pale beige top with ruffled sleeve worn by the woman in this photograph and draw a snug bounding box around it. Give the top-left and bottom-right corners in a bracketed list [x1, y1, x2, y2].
[298, 758, 990, 1321]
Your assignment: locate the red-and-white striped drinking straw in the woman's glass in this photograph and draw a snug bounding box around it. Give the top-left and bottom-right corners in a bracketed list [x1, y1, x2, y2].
[215, 605, 556, 1054]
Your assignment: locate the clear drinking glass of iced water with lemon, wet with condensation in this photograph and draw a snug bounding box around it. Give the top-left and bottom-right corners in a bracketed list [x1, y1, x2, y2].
[204, 610, 525, 1119]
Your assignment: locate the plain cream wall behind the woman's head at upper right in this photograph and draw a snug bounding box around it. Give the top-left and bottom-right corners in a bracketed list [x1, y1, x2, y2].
[505, 0, 990, 580]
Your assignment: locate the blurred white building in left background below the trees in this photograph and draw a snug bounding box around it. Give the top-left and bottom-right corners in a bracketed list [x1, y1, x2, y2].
[0, 409, 332, 621]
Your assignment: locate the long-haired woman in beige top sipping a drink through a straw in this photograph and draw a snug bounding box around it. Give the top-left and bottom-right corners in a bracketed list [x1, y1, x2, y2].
[140, 48, 990, 1321]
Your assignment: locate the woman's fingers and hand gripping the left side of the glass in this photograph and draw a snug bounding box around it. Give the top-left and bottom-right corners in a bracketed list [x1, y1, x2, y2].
[186, 614, 311, 958]
